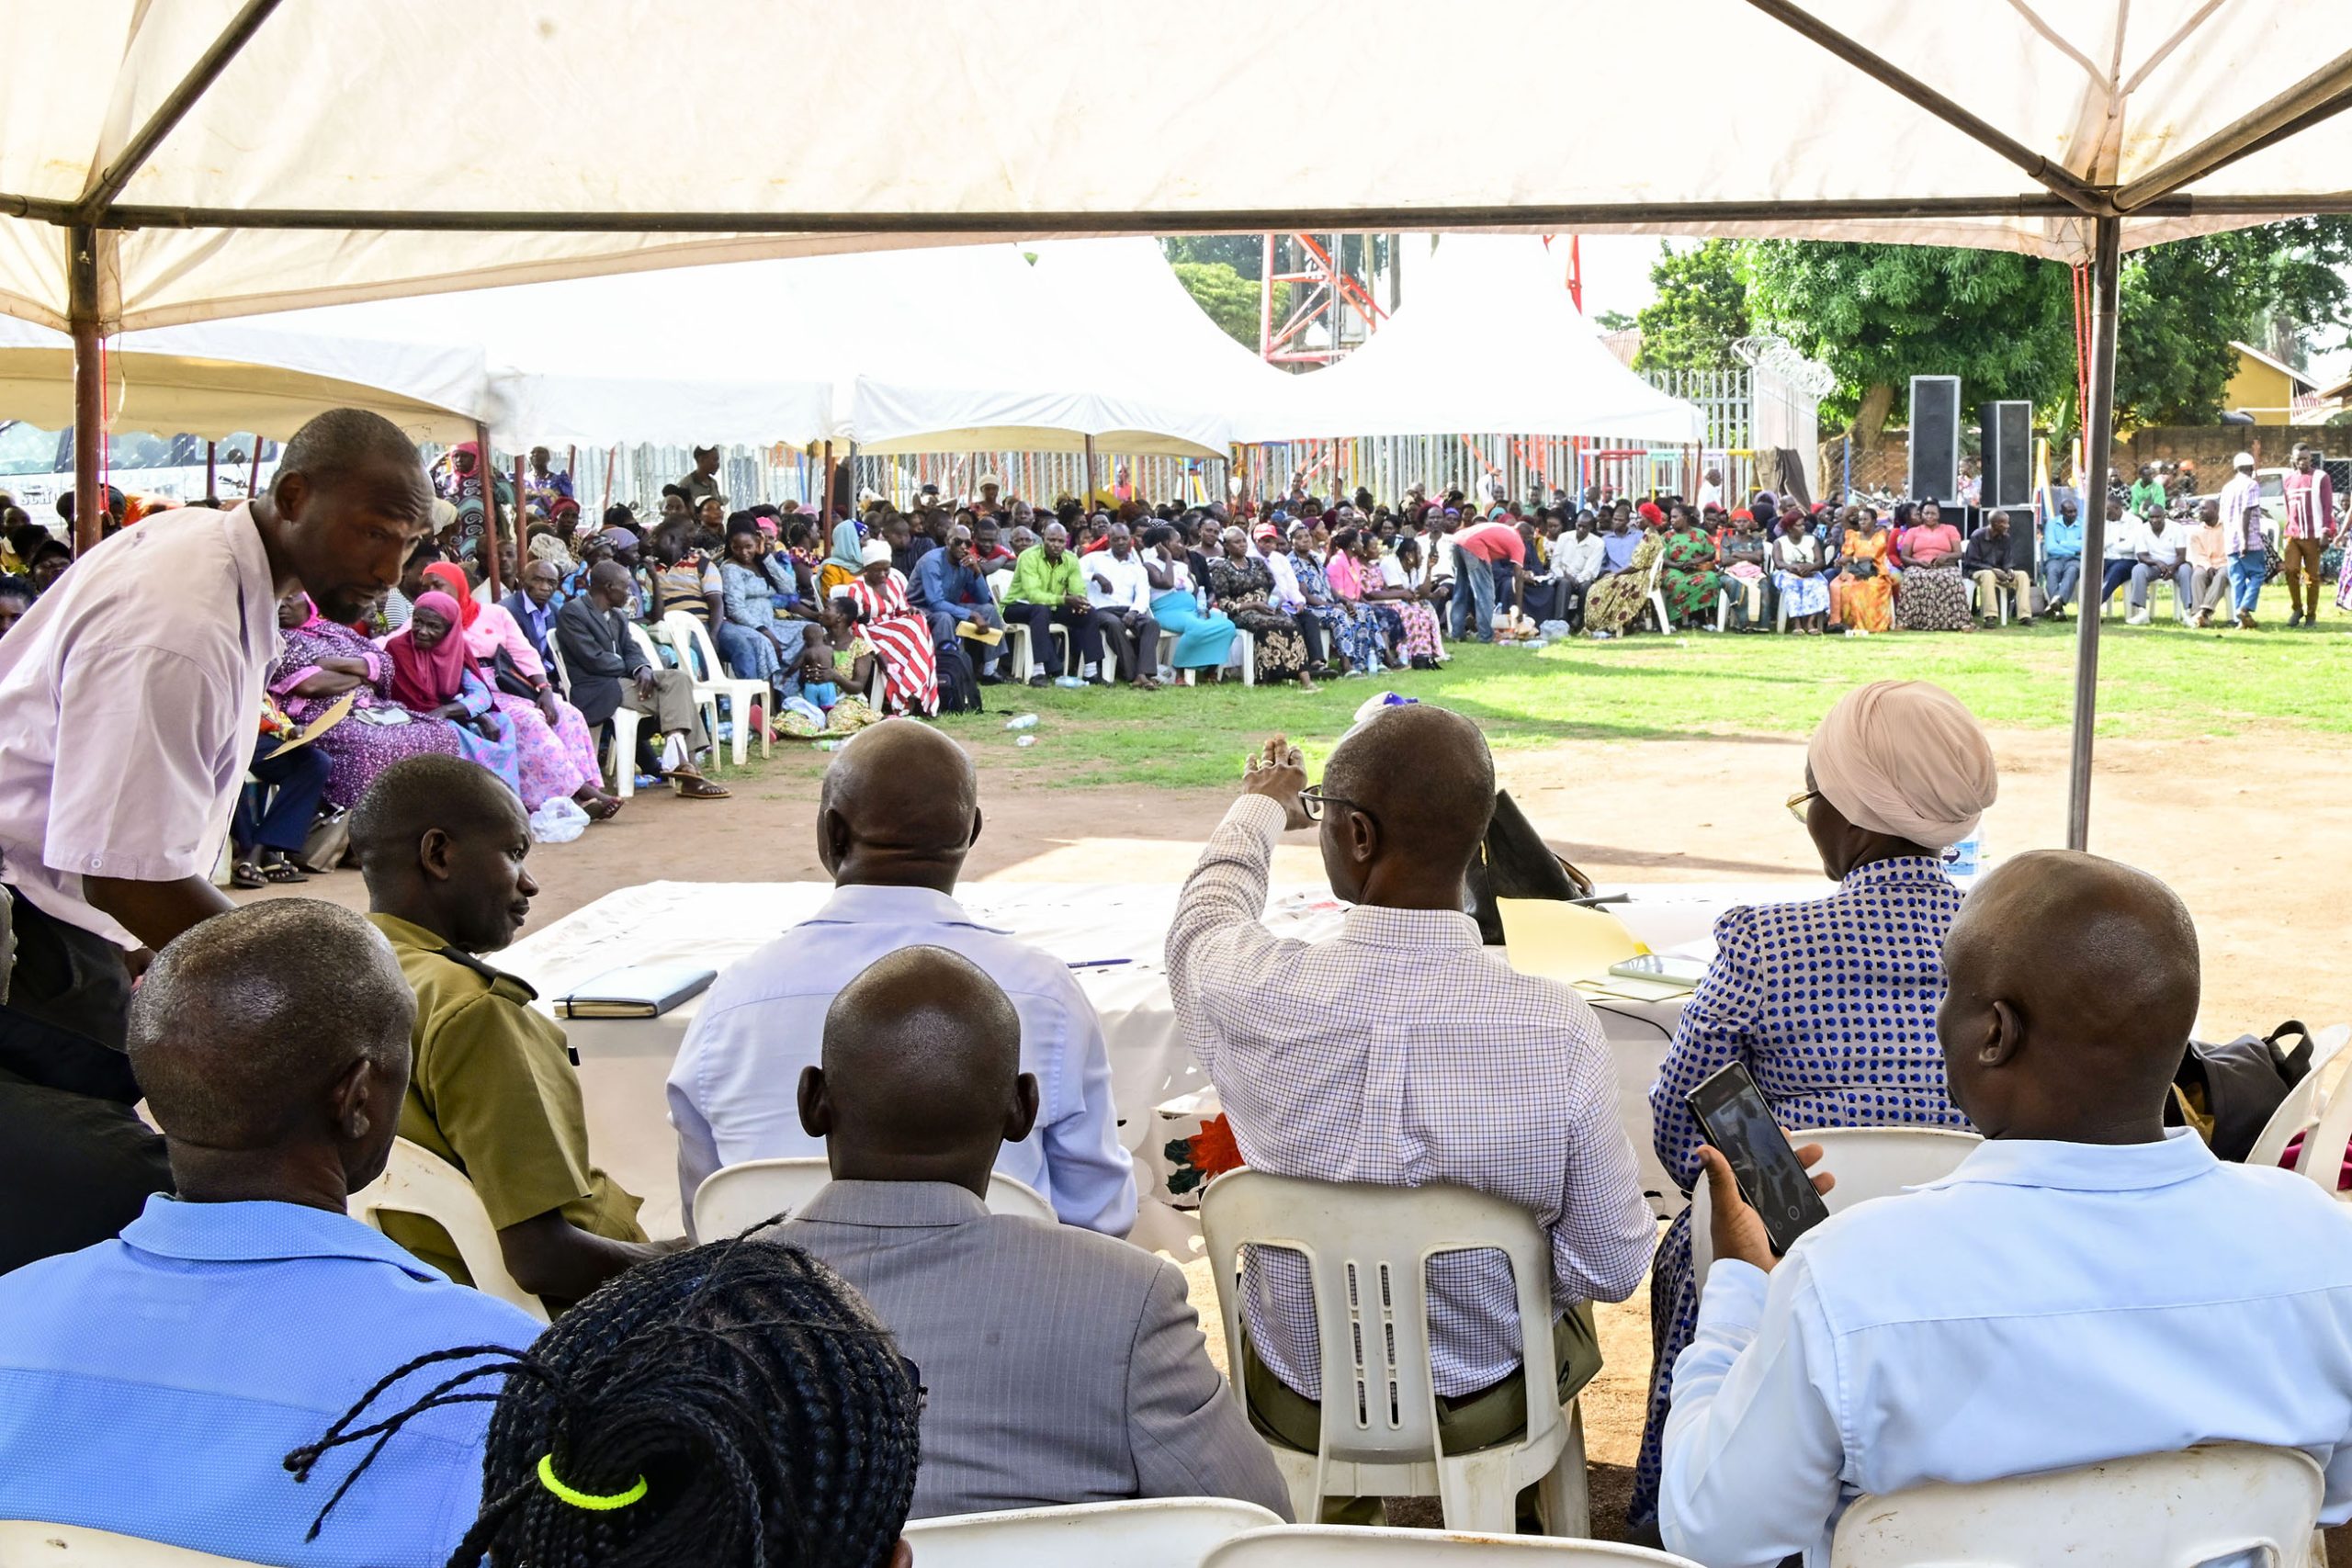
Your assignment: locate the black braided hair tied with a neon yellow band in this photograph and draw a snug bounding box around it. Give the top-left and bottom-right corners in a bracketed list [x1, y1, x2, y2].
[287, 1239, 922, 1568]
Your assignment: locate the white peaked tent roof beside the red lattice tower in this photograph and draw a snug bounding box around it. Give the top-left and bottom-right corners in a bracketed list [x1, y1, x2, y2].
[1239, 235, 1705, 442]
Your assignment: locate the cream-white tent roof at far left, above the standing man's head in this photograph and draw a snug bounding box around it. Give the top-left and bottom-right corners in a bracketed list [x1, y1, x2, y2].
[0, 317, 496, 442]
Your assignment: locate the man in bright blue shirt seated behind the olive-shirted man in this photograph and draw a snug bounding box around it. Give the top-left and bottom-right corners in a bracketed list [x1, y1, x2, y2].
[0, 898, 538, 1568]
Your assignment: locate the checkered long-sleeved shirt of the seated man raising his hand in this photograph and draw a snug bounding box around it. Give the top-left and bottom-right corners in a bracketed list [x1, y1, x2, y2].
[1167, 795, 1656, 1399]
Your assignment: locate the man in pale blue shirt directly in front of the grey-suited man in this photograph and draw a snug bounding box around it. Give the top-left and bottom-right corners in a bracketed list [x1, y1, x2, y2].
[671, 722, 1136, 1241]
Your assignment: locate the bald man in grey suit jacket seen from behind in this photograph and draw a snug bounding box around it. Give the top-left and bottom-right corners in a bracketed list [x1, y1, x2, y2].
[772, 947, 1291, 1518]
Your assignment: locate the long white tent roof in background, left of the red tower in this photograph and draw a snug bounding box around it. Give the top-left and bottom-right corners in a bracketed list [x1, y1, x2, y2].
[229, 243, 1226, 456]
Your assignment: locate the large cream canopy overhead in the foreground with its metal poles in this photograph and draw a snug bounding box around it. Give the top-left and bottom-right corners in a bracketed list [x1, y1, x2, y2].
[0, 0, 2352, 846]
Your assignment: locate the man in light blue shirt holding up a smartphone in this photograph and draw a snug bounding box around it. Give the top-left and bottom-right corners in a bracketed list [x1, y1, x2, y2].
[1658, 851, 2352, 1568]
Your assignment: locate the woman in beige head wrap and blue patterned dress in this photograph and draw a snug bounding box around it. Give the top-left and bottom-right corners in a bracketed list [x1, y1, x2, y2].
[1630, 682, 1999, 1523]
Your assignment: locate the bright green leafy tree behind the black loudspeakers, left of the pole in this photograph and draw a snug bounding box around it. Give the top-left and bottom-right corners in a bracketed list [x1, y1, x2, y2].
[1746, 240, 2075, 446]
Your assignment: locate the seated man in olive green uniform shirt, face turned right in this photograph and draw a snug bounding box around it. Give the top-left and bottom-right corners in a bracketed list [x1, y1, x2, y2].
[350, 755, 682, 1307]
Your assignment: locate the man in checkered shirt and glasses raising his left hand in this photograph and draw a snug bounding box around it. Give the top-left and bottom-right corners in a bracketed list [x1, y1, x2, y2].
[1167, 703, 1658, 1495]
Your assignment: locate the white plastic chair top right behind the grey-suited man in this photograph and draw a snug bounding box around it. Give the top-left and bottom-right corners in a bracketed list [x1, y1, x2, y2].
[906, 1497, 1282, 1568]
